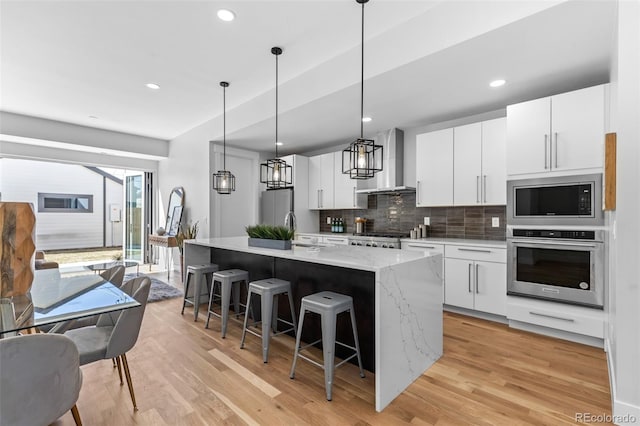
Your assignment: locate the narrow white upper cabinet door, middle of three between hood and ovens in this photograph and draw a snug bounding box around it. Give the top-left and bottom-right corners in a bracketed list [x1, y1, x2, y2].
[453, 123, 482, 206]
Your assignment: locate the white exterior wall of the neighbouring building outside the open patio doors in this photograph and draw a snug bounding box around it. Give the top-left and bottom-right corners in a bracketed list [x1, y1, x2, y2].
[0, 158, 122, 250]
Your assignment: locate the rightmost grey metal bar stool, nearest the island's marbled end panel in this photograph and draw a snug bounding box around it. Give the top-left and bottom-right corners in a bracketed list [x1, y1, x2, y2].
[289, 291, 364, 401]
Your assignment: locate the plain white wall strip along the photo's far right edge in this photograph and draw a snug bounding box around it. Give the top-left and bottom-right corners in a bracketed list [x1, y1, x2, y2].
[609, 0, 640, 424]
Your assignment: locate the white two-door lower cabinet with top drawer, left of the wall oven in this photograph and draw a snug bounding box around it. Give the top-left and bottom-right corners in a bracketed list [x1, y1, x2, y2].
[444, 245, 507, 315]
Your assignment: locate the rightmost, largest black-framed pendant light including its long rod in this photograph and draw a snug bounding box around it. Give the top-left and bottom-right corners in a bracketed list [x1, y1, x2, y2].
[342, 0, 382, 179]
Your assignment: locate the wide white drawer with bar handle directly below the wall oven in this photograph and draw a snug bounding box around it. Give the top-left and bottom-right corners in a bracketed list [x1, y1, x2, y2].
[507, 297, 604, 339]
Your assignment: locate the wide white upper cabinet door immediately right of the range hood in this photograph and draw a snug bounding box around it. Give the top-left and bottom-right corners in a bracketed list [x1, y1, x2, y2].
[416, 129, 453, 207]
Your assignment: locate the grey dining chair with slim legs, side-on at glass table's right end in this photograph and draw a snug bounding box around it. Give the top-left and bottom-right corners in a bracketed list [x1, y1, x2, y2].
[64, 277, 151, 411]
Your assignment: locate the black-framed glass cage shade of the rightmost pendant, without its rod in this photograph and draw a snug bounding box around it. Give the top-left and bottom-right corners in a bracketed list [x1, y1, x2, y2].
[342, 139, 382, 179]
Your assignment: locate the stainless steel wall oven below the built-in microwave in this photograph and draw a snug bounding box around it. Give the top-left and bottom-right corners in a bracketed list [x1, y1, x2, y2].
[507, 226, 605, 308]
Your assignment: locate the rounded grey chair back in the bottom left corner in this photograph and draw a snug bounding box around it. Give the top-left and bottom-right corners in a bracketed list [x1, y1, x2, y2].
[0, 334, 82, 425]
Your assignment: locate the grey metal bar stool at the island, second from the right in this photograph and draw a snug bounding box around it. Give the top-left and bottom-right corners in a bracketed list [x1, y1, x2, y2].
[240, 278, 298, 362]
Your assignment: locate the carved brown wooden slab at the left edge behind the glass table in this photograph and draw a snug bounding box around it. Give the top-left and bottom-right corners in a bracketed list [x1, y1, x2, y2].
[0, 202, 36, 297]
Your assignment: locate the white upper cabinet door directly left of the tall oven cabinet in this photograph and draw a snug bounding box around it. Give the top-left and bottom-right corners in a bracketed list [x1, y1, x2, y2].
[481, 117, 507, 204]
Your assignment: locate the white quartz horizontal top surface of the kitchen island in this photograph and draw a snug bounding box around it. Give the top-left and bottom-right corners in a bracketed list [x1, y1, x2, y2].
[185, 236, 439, 272]
